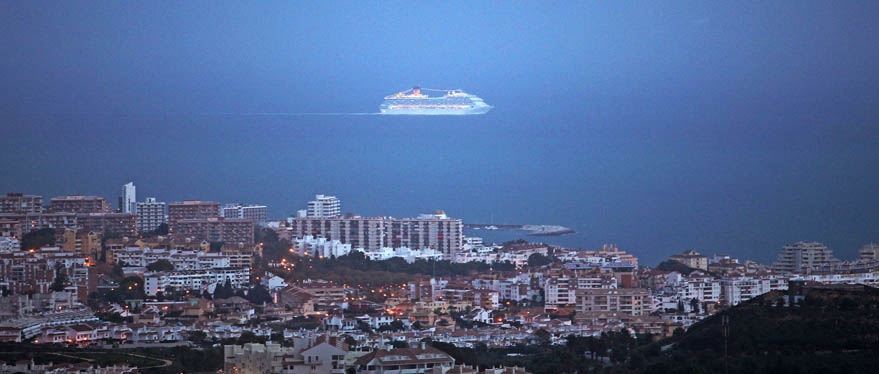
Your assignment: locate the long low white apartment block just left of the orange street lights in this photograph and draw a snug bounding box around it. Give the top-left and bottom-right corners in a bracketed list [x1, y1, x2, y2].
[144, 268, 250, 296]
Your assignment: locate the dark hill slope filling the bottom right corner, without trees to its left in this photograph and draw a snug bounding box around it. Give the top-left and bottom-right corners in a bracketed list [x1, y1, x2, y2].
[635, 282, 879, 373]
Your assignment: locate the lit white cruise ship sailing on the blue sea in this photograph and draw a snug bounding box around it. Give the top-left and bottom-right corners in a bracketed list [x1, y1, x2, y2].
[381, 87, 492, 115]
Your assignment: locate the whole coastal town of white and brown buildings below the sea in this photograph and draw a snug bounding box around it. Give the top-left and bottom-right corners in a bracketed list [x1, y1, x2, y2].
[0, 183, 879, 374]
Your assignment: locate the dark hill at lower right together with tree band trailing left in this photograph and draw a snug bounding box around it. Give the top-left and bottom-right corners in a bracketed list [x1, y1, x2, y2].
[435, 286, 879, 374]
